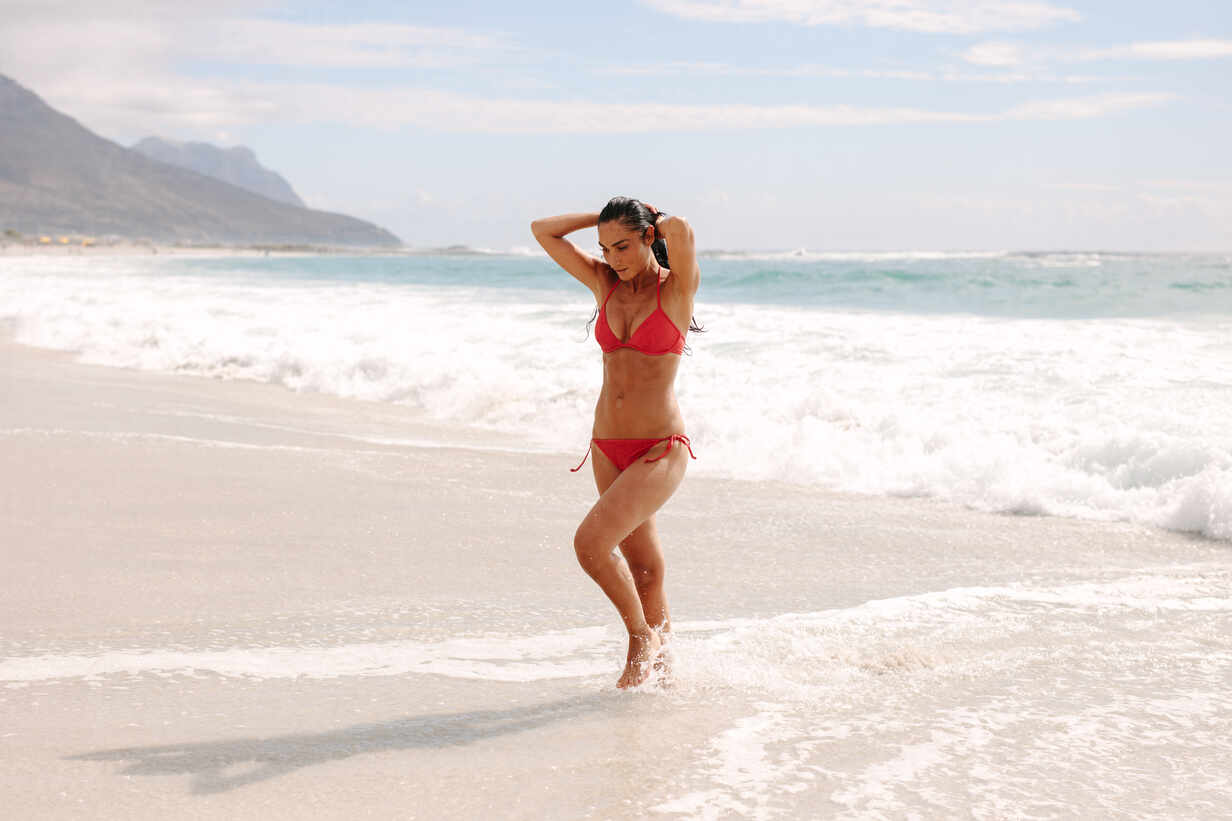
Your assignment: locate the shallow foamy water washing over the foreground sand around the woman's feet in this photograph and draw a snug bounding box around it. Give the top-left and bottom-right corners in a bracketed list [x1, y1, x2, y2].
[0, 562, 1232, 819]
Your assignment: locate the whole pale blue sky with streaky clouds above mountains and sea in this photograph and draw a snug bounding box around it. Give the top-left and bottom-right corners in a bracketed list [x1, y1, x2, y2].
[0, 0, 1232, 251]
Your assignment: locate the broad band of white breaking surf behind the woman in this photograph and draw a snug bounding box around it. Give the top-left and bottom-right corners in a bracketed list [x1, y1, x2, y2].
[0, 254, 1232, 540]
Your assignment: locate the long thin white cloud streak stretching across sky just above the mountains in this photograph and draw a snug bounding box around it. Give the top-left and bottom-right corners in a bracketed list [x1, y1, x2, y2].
[45, 78, 1173, 136]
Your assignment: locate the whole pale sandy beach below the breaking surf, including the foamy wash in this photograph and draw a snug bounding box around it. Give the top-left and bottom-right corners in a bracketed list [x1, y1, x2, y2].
[0, 343, 1232, 819]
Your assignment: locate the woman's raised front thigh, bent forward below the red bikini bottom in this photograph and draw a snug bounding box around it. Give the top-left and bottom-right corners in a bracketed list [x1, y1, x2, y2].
[578, 445, 689, 547]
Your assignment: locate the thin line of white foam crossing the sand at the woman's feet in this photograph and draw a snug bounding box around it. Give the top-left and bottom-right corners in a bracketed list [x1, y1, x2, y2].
[7, 567, 1232, 685]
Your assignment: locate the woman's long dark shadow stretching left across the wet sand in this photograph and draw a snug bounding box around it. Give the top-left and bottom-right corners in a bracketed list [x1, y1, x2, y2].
[67, 694, 618, 795]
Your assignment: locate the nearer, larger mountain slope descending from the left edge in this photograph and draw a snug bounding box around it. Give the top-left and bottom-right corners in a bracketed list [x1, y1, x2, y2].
[0, 74, 402, 247]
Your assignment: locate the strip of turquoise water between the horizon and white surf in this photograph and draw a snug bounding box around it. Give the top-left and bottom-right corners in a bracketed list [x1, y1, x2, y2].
[165, 246, 1232, 318]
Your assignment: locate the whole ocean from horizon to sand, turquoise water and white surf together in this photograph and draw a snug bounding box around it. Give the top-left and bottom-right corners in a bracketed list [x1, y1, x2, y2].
[0, 249, 1232, 540]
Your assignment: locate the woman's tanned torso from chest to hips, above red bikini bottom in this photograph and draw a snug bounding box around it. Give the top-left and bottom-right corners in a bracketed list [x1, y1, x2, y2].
[591, 268, 692, 439]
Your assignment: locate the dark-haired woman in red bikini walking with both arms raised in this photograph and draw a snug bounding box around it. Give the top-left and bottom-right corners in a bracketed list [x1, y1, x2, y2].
[531, 197, 701, 688]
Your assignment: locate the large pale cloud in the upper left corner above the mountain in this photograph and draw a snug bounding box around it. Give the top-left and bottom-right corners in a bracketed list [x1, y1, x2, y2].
[0, 10, 521, 139]
